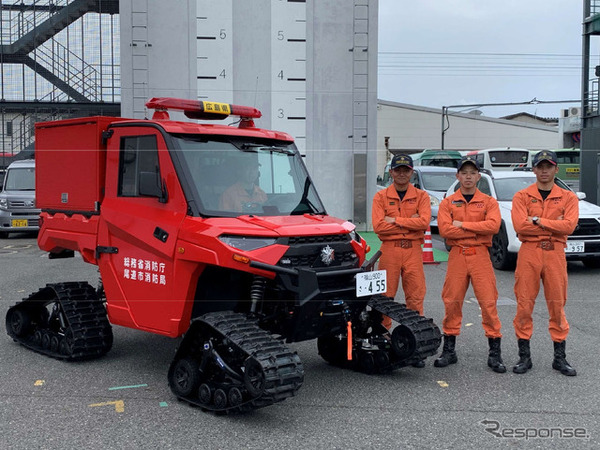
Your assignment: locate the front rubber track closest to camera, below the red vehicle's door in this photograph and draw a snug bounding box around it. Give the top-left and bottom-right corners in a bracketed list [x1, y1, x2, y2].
[173, 311, 304, 413]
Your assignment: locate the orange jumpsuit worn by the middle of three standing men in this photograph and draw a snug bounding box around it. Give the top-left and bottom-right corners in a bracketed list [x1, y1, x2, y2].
[438, 190, 502, 338]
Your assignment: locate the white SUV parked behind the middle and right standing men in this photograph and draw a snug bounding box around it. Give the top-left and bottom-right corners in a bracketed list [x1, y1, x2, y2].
[446, 171, 600, 270]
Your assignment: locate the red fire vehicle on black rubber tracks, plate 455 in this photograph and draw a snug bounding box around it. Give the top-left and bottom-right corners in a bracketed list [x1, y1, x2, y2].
[6, 98, 440, 412]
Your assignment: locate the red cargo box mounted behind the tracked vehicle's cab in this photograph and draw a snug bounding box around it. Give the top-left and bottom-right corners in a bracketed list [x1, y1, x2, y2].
[35, 116, 122, 213]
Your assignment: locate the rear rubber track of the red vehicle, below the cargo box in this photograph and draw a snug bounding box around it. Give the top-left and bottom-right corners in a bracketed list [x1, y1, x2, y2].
[7, 282, 113, 361]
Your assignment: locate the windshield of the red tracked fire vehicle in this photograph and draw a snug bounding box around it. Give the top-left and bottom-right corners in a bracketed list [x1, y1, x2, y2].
[175, 135, 325, 216]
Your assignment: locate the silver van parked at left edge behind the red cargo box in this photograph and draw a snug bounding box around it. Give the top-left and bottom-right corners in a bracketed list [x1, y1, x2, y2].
[0, 159, 40, 238]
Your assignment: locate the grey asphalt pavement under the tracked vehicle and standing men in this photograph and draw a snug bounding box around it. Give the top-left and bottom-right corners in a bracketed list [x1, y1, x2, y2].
[0, 234, 600, 449]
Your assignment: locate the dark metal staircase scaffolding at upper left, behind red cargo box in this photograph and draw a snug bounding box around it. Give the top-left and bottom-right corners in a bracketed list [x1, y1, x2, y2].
[0, 0, 121, 166]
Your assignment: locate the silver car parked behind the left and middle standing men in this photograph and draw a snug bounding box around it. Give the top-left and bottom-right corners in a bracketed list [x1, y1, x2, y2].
[378, 166, 456, 228]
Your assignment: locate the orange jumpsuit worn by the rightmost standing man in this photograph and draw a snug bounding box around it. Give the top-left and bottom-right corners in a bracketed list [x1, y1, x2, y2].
[512, 184, 579, 342]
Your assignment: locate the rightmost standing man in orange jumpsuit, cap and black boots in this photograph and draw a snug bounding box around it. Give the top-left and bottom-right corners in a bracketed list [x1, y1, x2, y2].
[512, 150, 579, 376]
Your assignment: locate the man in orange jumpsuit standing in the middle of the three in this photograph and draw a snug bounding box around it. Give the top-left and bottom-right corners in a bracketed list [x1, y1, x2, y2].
[434, 156, 506, 373]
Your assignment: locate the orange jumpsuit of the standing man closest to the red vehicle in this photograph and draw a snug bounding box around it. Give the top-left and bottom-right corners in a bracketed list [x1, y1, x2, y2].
[371, 184, 431, 329]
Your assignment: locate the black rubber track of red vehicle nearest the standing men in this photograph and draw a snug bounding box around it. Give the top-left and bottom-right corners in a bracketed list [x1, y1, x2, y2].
[368, 296, 442, 370]
